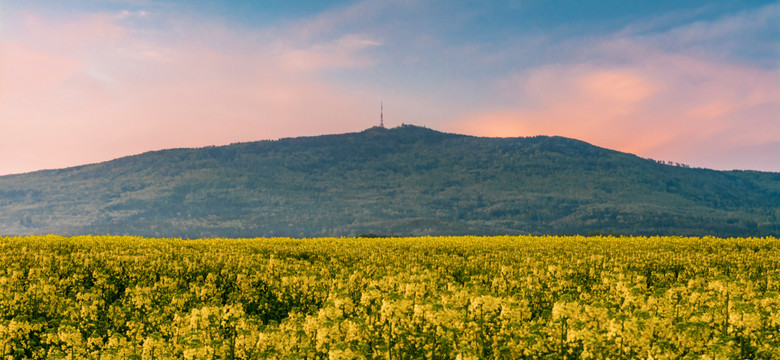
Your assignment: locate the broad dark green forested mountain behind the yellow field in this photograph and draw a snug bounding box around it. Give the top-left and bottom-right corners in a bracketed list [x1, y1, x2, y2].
[0, 125, 780, 238]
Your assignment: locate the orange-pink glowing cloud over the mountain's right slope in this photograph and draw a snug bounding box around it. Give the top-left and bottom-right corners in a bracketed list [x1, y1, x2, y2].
[453, 41, 780, 169]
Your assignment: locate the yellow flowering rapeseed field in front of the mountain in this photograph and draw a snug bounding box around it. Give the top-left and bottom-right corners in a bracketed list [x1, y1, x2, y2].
[0, 236, 780, 359]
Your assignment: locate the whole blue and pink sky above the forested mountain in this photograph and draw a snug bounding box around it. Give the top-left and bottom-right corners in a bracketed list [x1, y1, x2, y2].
[0, 0, 780, 175]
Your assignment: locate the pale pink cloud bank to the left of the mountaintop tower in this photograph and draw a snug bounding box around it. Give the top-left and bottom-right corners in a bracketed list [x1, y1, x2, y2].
[0, 10, 376, 174]
